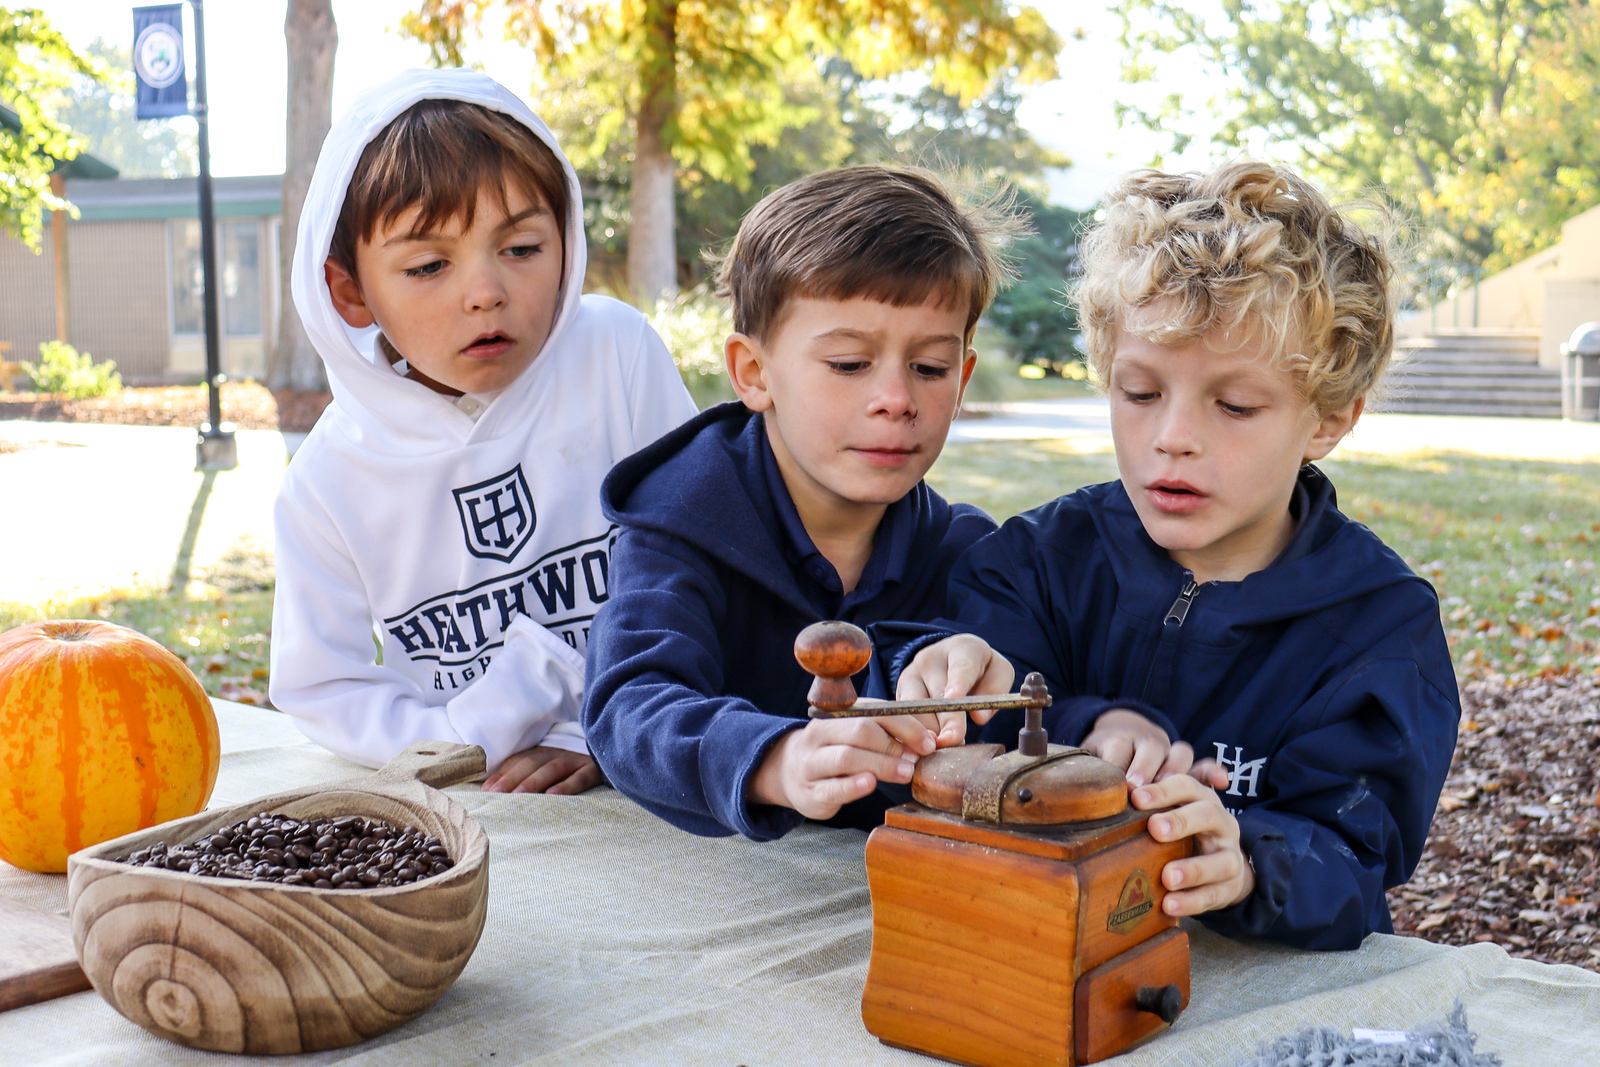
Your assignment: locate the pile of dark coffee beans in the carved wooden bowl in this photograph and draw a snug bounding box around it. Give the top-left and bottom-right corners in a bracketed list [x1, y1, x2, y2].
[123, 813, 454, 889]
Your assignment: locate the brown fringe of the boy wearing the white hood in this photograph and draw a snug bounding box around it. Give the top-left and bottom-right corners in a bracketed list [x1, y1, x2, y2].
[328, 99, 570, 278]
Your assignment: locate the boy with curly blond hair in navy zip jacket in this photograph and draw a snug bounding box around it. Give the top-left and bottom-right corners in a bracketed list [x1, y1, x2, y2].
[886, 163, 1461, 949]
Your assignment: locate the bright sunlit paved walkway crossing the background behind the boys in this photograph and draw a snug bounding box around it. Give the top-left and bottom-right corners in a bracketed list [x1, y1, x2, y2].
[0, 406, 1600, 603]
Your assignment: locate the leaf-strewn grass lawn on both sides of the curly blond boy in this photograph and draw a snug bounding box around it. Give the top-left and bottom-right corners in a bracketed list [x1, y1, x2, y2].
[930, 442, 1600, 678]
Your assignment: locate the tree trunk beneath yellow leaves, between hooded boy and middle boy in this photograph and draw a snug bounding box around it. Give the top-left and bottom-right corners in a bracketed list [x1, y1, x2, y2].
[627, 0, 678, 312]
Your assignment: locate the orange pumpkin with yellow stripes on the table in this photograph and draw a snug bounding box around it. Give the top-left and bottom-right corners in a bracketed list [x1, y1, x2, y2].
[0, 621, 221, 872]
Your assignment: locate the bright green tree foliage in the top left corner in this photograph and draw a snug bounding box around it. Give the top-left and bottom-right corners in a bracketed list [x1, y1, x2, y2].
[0, 8, 104, 251]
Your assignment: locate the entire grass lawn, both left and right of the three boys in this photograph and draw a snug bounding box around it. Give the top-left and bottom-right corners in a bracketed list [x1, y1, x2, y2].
[0, 435, 1600, 704]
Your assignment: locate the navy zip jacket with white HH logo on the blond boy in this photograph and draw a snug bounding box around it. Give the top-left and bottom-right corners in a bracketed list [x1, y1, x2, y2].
[875, 467, 1461, 949]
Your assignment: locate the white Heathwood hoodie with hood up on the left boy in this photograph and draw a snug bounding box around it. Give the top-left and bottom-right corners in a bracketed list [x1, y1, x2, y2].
[270, 70, 694, 771]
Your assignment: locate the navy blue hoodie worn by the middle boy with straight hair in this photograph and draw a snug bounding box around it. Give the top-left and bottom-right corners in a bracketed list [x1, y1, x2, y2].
[584, 403, 995, 840]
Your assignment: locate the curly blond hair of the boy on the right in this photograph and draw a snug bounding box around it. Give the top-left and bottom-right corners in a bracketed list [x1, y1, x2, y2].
[1075, 162, 1394, 416]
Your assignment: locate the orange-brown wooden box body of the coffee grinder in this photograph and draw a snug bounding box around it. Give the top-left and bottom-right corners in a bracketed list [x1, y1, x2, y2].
[861, 783, 1194, 1067]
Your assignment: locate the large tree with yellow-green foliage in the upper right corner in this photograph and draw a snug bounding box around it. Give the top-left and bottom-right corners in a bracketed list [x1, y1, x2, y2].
[1120, 0, 1600, 289]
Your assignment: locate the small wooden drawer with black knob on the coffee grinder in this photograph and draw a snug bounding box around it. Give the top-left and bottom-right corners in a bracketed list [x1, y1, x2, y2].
[1072, 929, 1189, 1067]
